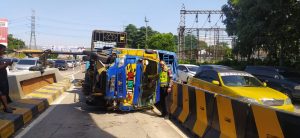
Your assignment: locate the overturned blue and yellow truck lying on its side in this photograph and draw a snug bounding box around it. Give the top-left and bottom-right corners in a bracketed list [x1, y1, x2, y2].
[83, 30, 177, 111]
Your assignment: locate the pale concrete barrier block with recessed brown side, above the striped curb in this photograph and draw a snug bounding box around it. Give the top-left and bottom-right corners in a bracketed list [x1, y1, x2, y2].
[8, 68, 64, 100]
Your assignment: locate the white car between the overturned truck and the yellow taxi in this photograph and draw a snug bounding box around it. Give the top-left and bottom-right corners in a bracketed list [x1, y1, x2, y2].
[177, 64, 199, 83]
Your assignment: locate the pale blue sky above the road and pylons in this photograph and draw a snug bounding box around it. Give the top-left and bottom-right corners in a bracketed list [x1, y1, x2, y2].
[0, 0, 227, 48]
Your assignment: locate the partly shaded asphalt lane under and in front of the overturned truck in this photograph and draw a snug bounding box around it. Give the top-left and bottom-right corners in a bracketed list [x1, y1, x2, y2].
[16, 67, 186, 138]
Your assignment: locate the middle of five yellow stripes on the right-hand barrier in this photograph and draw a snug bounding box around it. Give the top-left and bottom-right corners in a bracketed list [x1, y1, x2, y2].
[193, 89, 208, 137]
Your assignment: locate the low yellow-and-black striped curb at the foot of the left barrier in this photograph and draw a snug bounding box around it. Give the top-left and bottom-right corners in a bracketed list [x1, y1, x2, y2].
[0, 79, 71, 138]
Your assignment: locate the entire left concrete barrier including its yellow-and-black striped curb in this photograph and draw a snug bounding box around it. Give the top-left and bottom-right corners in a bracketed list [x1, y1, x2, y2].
[0, 69, 71, 138]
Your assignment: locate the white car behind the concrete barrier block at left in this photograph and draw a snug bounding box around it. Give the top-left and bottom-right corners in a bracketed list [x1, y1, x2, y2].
[15, 58, 38, 70]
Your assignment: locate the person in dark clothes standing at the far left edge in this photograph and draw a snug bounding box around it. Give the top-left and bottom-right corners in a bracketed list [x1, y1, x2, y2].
[0, 44, 15, 113]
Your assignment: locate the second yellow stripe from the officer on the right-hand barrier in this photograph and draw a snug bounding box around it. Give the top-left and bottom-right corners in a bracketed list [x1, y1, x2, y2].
[178, 85, 190, 123]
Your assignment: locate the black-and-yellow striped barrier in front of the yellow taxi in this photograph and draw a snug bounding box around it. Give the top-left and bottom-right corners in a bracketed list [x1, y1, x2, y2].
[169, 83, 300, 138]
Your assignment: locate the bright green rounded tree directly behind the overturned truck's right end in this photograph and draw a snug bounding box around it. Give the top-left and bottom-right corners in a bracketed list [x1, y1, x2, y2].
[148, 33, 176, 52]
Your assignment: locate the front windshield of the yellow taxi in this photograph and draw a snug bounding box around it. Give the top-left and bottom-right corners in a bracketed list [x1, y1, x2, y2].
[222, 75, 263, 87]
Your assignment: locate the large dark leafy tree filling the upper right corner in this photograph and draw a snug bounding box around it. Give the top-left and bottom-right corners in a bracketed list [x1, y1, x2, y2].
[222, 0, 300, 65]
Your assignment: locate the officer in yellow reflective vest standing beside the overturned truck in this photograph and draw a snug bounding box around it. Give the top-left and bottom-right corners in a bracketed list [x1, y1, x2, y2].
[159, 61, 173, 117]
